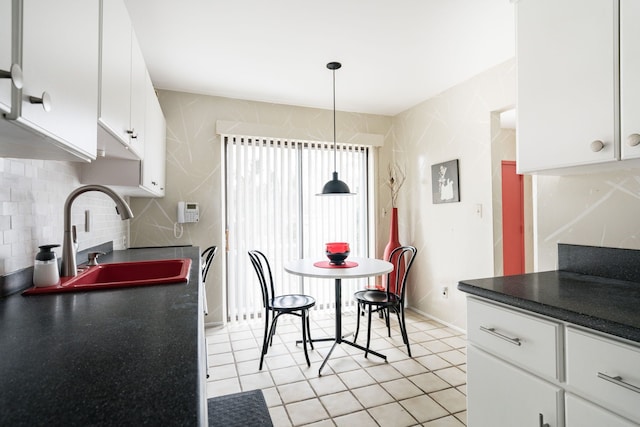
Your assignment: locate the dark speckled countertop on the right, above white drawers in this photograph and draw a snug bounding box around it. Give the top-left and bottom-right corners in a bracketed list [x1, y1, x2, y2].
[458, 271, 640, 343]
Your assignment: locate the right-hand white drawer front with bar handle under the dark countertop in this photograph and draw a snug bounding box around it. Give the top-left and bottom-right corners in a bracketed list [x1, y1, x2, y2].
[567, 328, 640, 423]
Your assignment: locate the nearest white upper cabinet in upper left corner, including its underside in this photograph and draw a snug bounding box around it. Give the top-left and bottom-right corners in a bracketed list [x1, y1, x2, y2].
[0, 0, 99, 161]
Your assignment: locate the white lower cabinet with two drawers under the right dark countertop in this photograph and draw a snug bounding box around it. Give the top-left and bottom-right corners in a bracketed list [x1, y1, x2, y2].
[467, 297, 640, 427]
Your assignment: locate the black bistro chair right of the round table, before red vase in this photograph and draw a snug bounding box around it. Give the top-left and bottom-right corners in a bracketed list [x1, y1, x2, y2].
[353, 246, 417, 357]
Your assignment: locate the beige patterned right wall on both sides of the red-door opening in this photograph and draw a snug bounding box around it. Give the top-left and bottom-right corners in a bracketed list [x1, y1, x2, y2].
[388, 60, 640, 328]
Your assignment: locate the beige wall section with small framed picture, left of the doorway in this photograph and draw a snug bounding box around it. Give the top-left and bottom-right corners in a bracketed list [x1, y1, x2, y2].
[379, 61, 515, 328]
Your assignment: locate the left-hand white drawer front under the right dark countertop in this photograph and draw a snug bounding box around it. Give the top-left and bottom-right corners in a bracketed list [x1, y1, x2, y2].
[467, 298, 563, 380]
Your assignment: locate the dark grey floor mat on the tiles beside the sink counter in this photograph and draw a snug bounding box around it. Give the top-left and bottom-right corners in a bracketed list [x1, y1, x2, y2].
[207, 390, 273, 427]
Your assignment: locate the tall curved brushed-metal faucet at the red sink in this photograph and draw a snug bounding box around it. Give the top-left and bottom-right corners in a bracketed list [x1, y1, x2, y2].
[61, 185, 133, 277]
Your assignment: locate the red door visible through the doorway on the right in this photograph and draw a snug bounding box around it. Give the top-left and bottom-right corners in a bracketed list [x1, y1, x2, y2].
[502, 160, 525, 276]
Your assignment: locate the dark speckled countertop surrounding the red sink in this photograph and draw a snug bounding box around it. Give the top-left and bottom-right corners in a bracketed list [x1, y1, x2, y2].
[0, 247, 207, 426]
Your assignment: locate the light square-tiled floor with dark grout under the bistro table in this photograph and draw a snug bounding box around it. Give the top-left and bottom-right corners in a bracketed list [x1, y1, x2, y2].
[207, 309, 467, 427]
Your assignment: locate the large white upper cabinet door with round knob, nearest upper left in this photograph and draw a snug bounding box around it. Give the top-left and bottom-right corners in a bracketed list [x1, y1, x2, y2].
[18, 0, 99, 158]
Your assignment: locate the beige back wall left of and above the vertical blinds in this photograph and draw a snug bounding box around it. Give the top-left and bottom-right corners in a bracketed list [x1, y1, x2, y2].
[131, 91, 391, 323]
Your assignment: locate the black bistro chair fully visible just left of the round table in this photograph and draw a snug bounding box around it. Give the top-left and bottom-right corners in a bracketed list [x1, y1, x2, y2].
[249, 250, 316, 370]
